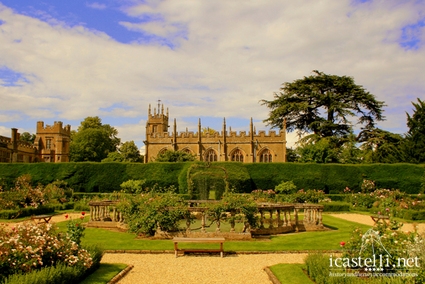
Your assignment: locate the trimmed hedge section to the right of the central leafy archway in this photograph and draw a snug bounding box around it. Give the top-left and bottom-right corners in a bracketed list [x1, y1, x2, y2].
[246, 163, 425, 194]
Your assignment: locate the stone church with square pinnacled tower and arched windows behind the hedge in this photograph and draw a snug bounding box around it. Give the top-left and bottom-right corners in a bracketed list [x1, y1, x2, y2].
[144, 104, 286, 163]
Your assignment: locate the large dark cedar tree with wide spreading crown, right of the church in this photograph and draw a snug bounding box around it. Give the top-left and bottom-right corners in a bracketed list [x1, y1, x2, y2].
[261, 70, 384, 137]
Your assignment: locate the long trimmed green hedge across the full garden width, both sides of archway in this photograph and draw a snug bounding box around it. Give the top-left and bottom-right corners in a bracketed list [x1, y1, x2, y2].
[0, 162, 425, 194]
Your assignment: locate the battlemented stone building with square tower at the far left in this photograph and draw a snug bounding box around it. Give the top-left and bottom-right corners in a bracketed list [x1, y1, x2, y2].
[0, 121, 71, 163]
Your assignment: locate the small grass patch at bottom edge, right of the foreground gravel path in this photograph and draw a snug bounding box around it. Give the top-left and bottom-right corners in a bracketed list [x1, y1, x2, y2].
[270, 263, 314, 284]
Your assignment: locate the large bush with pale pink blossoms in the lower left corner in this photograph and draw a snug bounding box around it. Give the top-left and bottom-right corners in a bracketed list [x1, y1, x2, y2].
[0, 222, 93, 278]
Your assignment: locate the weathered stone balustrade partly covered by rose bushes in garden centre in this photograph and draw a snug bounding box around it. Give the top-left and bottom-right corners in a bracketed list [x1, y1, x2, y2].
[88, 200, 324, 236]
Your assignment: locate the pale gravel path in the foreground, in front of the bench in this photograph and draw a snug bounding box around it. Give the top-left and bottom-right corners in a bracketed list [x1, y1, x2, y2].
[102, 253, 307, 284]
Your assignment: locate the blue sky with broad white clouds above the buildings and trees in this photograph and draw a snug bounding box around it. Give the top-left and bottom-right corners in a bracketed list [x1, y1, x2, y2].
[0, 0, 425, 153]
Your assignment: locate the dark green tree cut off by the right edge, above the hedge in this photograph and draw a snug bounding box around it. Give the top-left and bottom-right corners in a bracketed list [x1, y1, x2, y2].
[405, 98, 425, 163]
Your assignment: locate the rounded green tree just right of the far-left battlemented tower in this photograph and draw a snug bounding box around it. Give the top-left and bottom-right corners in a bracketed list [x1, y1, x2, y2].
[70, 116, 120, 162]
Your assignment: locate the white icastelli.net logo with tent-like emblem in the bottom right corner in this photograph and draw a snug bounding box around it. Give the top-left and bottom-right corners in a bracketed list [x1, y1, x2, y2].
[329, 229, 421, 277]
